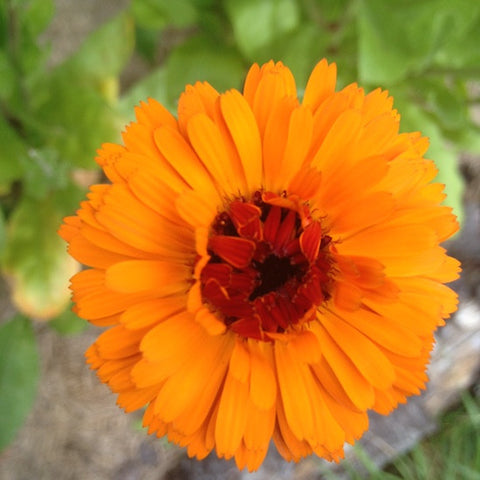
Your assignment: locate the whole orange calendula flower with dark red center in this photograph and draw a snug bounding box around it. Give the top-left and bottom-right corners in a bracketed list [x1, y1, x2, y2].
[61, 60, 459, 470]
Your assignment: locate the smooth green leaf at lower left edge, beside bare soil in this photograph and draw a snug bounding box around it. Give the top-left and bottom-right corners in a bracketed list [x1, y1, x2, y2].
[0, 316, 39, 450]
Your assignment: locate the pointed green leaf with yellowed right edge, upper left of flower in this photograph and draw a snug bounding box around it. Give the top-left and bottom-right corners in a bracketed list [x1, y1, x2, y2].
[28, 14, 133, 169]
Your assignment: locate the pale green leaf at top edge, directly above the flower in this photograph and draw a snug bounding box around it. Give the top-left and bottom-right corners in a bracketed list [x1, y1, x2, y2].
[225, 0, 300, 62]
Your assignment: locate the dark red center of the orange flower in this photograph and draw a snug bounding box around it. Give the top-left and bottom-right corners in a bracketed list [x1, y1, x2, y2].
[200, 191, 331, 340]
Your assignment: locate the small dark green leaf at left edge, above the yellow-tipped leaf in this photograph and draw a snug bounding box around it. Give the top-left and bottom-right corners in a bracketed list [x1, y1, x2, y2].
[0, 115, 28, 186]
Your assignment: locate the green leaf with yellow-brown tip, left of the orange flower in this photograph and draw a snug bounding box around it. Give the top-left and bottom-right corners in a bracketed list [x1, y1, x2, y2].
[3, 196, 79, 320]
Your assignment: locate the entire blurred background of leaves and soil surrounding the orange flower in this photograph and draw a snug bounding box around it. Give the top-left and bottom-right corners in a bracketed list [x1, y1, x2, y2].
[0, 0, 480, 480]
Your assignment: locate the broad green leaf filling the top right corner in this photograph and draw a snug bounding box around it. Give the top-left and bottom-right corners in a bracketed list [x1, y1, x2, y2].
[358, 0, 480, 84]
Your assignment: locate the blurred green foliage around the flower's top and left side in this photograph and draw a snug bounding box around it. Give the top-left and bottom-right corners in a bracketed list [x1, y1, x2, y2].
[0, 0, 480, 454]
